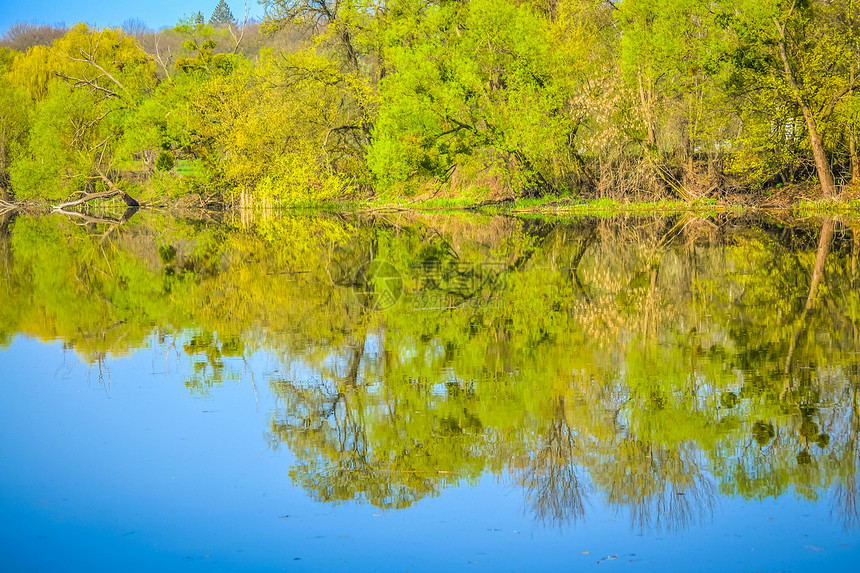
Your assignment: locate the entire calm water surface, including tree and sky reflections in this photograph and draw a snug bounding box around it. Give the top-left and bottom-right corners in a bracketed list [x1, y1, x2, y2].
[0, 212, 860, 571]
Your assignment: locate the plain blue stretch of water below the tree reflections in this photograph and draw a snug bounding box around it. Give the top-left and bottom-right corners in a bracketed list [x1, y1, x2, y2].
[0, 336, 860, 571]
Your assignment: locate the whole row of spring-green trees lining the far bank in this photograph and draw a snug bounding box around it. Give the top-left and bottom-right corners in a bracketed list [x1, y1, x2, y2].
[0, 0, 860, 204]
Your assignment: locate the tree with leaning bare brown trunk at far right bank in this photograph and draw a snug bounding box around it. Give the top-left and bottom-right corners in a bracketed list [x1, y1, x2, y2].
[714, 0, 860, 197]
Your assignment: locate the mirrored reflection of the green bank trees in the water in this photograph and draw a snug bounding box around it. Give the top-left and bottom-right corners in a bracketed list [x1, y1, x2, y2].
[0, 212, 860, 529]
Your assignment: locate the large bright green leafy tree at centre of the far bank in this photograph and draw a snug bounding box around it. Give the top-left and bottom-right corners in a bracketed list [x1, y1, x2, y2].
[369, 0, 582, 196]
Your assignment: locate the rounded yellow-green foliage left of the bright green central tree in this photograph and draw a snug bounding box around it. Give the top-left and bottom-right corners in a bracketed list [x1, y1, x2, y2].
[193, 51, 362, 201]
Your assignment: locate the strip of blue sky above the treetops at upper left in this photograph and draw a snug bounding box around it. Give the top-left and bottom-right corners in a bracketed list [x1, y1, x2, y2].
[0, 0, 263, 31]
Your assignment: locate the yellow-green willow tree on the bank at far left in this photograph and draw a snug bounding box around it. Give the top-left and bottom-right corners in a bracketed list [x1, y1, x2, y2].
[10, 24, 155, 204]
